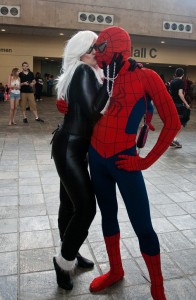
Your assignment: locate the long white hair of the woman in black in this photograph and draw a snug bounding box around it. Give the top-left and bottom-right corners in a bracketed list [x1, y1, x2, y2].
[56, 30, 100, 101]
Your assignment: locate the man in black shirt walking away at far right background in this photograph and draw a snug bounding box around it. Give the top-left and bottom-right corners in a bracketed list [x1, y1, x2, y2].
[170, 68, 190, 148]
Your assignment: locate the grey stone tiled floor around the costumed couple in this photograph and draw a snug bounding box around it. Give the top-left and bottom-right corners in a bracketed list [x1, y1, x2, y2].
[0, 98, 196, 300]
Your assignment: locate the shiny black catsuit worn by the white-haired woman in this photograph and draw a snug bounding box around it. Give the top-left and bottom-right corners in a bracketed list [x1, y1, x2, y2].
[52, 64, 108, 261]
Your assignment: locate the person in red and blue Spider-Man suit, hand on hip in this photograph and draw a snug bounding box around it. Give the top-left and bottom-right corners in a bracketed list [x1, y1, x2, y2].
[89, 27, 180, 300]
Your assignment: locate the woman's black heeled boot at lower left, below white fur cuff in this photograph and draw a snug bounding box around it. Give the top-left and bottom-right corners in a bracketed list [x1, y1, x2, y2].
[53, 257, 73, 290]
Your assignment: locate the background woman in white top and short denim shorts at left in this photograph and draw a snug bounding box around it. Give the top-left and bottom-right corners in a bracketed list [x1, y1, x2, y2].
[8, 68, 20, 125]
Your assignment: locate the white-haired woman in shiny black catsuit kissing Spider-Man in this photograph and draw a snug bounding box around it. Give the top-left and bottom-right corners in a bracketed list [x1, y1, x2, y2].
[52, 31, 122, 290]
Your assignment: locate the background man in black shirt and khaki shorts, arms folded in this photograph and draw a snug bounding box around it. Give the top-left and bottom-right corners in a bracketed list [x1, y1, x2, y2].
[19, 62, 44, 123]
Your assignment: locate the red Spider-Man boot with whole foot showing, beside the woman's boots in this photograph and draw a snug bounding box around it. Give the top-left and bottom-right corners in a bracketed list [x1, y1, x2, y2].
[90, 233, 124, 292]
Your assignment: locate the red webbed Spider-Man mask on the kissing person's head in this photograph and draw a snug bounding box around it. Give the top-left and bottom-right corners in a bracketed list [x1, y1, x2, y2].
[95, 26, 131, 68]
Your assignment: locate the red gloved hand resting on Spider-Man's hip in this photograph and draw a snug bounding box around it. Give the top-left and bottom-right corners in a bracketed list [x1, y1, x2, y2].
[116, 155, 143, 171]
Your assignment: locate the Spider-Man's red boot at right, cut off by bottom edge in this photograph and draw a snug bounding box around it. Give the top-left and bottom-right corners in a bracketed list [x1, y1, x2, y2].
[142, 253, 166, 300]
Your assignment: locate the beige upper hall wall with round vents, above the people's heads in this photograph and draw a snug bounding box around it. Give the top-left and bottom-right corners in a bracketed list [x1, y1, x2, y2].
[0, 0, 196, 98]
